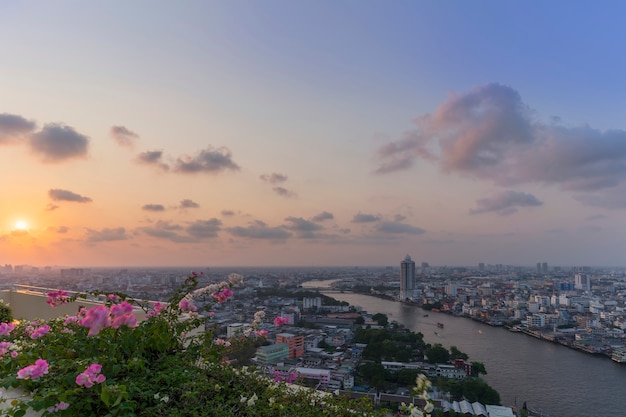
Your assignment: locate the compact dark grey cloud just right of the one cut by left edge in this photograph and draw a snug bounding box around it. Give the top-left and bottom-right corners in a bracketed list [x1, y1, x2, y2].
[30, 123, 89, 163]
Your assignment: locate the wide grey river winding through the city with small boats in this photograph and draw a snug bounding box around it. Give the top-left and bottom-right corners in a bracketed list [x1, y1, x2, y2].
[305, 281, 626, 417]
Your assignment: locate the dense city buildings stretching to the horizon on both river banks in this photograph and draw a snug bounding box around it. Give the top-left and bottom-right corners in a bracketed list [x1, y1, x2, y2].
[0, 255, 626, 416]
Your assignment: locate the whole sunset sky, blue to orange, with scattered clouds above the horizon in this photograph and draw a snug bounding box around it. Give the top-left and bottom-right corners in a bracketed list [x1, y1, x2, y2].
[0, 0, 626, 267]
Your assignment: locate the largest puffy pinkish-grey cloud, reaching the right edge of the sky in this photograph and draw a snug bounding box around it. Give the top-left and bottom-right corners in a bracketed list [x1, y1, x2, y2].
[375, 84, 626, 197]
